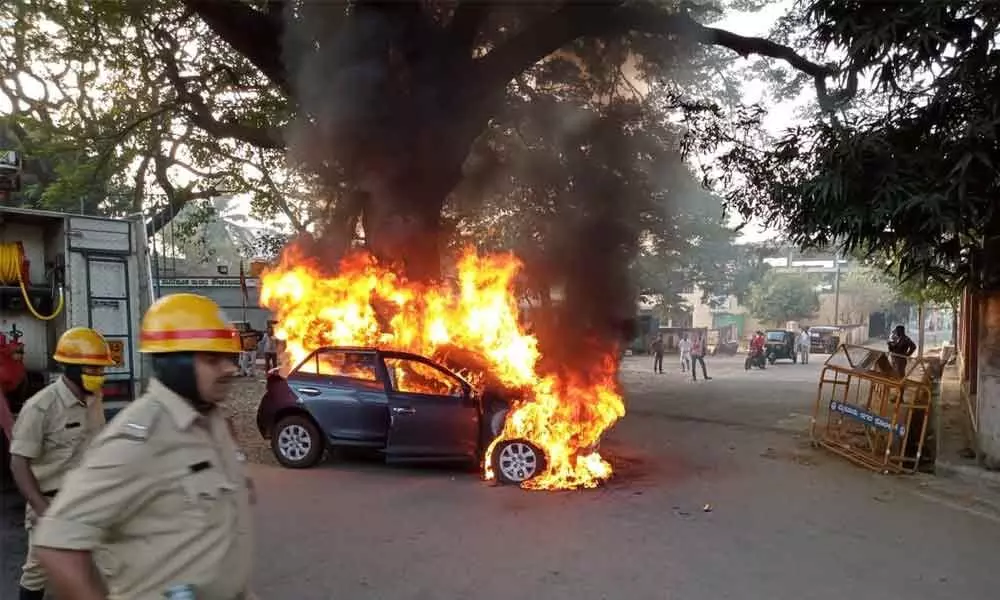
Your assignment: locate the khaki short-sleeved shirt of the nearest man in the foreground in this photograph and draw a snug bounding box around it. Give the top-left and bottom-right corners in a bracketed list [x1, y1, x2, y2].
[34, 380, 253, 600]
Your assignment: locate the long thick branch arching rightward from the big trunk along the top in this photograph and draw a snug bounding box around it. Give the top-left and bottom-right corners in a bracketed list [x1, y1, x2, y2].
[476, 0, 836, 101]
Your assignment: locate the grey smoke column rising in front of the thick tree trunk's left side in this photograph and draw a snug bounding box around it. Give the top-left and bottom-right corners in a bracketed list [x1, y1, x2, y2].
[283, 2, 418, 266]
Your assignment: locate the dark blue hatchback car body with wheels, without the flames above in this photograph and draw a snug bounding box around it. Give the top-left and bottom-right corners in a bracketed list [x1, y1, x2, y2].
[257, 346, 546, 484]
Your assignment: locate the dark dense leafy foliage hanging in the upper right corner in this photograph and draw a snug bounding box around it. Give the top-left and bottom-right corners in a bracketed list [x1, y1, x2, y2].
[722, 0, 1000, 288]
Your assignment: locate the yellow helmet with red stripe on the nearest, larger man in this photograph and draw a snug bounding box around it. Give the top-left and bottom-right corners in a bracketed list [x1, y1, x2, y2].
[139, 294, 240, 354]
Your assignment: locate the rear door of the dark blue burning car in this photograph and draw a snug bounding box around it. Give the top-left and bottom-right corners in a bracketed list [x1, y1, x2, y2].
[288, 349, 389, 446]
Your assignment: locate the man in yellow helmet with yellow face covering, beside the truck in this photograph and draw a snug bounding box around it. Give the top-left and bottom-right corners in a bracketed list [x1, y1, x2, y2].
[10, 327, 114, 600]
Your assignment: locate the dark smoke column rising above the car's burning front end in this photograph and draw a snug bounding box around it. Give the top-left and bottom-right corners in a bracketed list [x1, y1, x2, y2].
[498, 102, 650, 371]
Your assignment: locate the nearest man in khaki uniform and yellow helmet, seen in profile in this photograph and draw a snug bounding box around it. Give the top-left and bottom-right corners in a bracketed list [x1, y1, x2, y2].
[35, 294, 253, 600]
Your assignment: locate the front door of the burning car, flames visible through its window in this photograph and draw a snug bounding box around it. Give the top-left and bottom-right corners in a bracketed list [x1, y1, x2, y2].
[382, 352, 479, 458]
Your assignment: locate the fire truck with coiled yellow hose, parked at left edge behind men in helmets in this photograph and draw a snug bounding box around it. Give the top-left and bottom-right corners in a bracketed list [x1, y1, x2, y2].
[0, 207, 153, 479]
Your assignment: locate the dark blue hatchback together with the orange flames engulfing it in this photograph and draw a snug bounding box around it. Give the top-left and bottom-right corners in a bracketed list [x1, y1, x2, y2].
[254, 246, 625, 490]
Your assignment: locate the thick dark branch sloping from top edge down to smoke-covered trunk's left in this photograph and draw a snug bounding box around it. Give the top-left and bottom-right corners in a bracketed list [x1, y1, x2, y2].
[184, 0, 291, 95]
